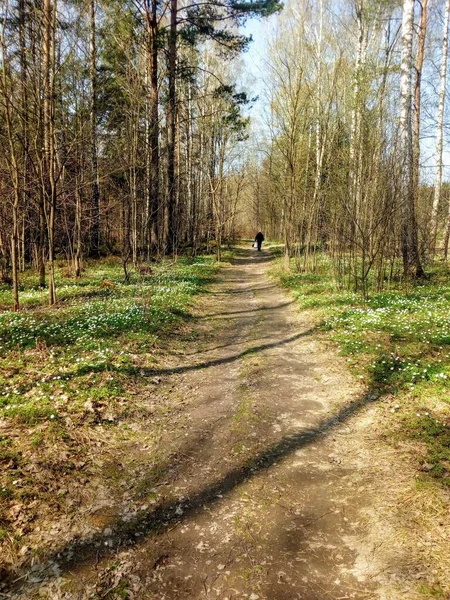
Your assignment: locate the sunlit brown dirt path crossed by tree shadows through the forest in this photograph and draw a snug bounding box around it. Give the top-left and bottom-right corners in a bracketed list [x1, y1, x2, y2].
[8, 250, 430, 600]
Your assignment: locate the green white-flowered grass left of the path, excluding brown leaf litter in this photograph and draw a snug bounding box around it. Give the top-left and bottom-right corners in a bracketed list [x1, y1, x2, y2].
[0, 257, 217, 425]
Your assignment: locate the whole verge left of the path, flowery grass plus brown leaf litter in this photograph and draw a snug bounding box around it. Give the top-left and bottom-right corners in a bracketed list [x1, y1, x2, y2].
[0, 257, 218, 579]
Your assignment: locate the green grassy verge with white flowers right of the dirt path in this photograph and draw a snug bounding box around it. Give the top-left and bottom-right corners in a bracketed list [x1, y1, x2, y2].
[273, 259, 450, 487]
